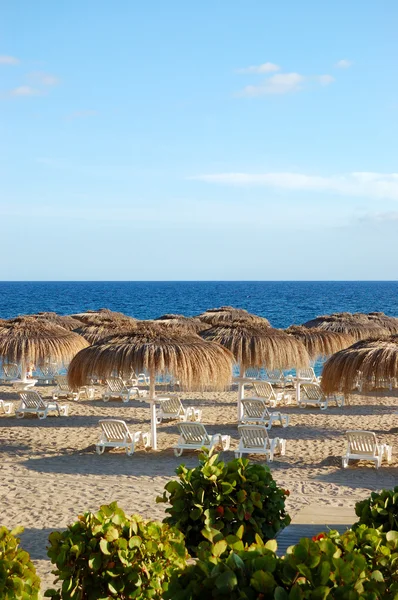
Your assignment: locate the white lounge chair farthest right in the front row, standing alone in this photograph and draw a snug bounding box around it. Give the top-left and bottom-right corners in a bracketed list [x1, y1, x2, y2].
[342, 430, 392, 469]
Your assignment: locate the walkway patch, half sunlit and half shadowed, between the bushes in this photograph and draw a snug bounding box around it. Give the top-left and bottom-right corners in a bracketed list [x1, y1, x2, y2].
[277, 504, 358, 556]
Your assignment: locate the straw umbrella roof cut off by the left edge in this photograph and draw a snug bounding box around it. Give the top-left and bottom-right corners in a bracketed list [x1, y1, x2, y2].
[0, 317, 88, 365]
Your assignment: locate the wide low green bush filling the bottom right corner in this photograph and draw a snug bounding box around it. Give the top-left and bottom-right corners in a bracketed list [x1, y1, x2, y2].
[164, 525, 398, 600]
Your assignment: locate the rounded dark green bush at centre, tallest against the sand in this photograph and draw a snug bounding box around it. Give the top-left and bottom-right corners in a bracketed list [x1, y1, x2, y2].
[156, 453, 290, 555]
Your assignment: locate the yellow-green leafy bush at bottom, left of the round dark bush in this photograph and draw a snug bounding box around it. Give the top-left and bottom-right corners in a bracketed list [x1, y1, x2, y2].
[45, 502, 187, 600]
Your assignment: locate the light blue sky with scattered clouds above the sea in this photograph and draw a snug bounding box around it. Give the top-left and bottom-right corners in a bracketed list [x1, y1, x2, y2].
[0, 0, 398, 281]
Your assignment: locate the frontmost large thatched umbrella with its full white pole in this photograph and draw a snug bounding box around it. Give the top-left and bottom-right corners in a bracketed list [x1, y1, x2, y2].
[68, 328, 233, 449]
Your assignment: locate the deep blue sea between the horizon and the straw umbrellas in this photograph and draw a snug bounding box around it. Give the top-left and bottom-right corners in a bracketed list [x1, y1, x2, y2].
[0, 281, 398, 327]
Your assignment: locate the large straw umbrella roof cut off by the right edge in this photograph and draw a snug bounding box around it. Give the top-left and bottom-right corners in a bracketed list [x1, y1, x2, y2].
[322, 335, 398, 393]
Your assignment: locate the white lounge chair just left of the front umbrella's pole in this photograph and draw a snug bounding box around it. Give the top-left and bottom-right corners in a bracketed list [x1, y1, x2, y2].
[95, 419, 151, 456]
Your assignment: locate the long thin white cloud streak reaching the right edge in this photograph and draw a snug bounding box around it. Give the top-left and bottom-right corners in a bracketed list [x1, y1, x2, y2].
[190, 172, 398, 200]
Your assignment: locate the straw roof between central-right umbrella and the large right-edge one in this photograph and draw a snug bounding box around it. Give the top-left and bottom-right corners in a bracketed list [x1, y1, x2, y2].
[285, 325, 355, 360]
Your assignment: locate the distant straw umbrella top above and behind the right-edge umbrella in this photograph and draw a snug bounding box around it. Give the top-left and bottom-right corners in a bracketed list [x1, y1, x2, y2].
[304, 313, 389, 340]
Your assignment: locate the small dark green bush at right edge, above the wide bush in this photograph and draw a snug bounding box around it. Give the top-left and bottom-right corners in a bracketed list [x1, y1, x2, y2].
[353, 486, 398, 531]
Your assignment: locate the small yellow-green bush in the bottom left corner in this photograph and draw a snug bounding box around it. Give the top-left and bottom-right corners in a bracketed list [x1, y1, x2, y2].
[0, 527, 40, 600]
